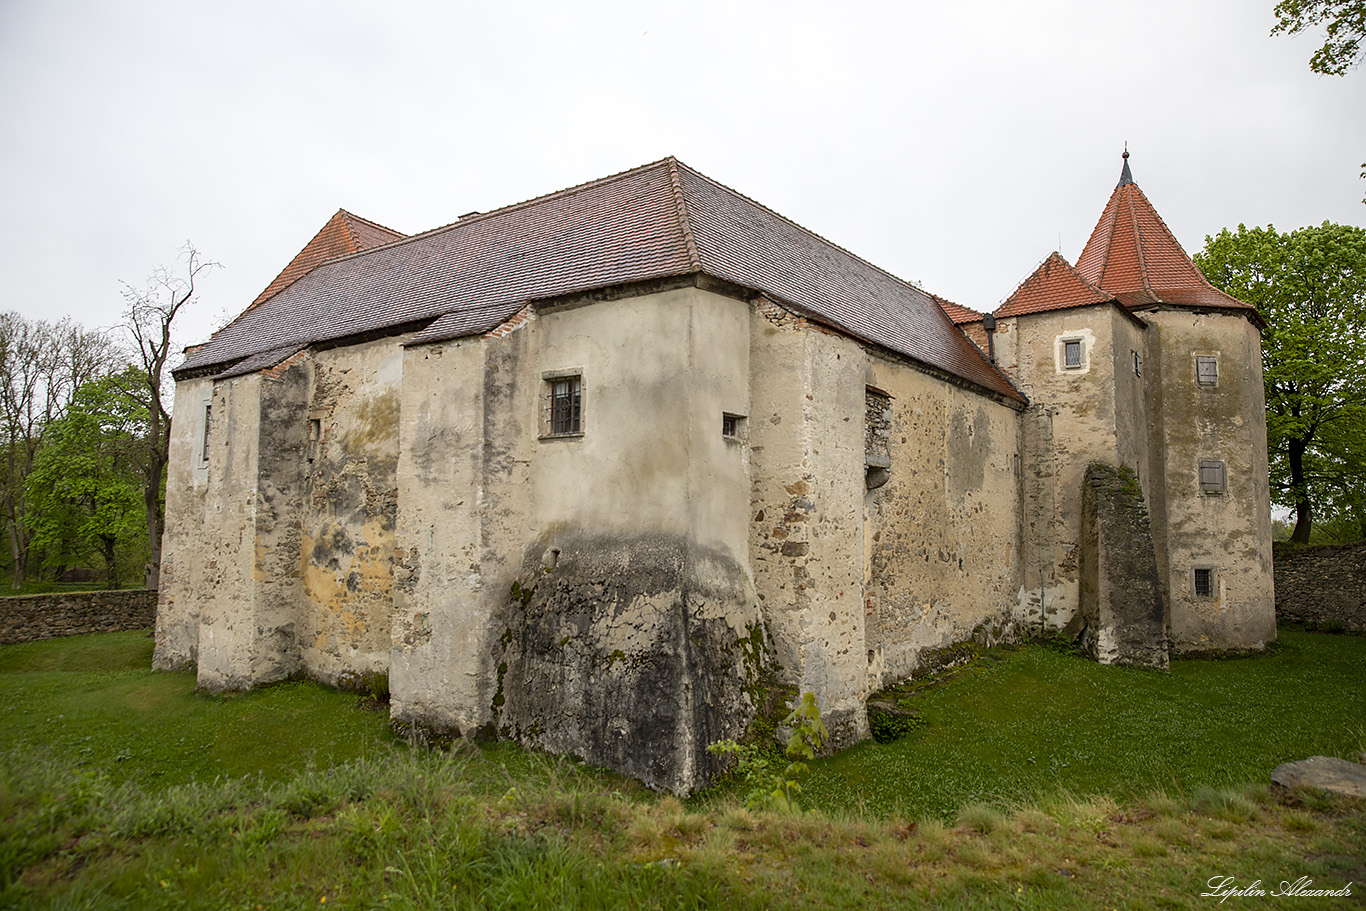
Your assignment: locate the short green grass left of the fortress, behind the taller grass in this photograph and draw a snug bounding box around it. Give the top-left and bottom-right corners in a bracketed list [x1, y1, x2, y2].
[0, 631, 392, 787]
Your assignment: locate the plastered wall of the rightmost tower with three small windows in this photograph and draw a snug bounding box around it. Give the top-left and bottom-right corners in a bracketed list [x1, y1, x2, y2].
[1143, 310, 1276, 653]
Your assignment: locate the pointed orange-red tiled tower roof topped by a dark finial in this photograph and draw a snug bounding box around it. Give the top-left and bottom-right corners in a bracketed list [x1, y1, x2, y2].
[1076, 152, 1255, 313]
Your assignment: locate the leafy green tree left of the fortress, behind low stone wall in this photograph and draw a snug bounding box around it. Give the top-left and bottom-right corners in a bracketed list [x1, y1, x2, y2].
[26, 367, 148, 589]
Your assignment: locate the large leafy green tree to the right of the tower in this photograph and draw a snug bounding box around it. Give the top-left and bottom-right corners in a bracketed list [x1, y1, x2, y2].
[1195, 221, 1366, 544]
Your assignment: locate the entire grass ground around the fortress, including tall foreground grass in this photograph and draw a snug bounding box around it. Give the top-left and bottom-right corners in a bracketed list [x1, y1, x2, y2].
[0, 631, 1366, 911]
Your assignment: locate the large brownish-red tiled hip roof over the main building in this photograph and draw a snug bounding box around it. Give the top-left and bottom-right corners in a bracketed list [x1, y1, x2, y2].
[178, 158, 1023, 400]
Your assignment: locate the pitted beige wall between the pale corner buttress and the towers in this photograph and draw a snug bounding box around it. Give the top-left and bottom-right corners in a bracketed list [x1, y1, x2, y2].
[851, 355, 1020, 690]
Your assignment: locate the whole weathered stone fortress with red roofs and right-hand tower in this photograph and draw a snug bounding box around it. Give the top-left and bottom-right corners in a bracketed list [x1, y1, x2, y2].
[156, 153, 1276, 792]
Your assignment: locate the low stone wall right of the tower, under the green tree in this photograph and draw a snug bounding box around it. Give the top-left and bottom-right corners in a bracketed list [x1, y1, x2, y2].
[1274, 542, 1366, 632]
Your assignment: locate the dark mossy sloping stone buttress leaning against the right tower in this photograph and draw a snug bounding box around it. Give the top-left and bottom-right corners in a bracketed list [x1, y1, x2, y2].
[1071, 463, 1169, 671]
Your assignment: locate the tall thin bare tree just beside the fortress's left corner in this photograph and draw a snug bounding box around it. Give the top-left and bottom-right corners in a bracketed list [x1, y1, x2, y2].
[123, 240, 219, 589]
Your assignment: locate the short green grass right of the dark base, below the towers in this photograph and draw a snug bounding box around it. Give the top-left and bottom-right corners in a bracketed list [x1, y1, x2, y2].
[806, 630, 1366, 818]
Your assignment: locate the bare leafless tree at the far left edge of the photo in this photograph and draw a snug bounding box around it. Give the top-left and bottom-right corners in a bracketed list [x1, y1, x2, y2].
[0, 313, 122, 589]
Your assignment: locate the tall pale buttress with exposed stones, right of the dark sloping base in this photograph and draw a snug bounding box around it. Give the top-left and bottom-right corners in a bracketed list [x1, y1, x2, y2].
[750, 303, 867, 747]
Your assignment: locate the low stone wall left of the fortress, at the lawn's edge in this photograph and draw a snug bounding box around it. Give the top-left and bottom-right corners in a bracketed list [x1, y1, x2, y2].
[0, 589, 157, 645]
